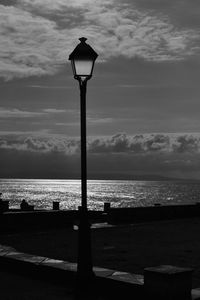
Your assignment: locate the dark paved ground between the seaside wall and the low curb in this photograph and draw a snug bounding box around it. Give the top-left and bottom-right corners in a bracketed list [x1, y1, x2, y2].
[0, 218, 200, 288]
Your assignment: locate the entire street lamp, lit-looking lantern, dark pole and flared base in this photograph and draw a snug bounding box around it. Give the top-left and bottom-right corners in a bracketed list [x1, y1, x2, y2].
[69, 37, 98, 293]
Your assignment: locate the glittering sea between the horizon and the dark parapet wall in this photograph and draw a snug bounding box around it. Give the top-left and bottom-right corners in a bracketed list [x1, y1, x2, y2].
[0, 179, 200, 210]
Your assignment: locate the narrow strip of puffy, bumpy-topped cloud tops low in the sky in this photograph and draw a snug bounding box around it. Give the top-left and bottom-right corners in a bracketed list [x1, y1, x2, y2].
[0, 133, 200, 155]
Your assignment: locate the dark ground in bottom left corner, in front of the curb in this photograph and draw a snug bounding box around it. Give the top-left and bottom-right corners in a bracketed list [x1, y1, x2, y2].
[0, 271, 73, 300]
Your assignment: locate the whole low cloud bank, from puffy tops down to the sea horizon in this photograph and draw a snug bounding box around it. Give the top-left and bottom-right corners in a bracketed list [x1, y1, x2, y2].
[0, 133, 200, 179]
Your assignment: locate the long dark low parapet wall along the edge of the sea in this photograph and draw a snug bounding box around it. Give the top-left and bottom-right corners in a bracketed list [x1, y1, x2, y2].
[0, 204, 200, 232]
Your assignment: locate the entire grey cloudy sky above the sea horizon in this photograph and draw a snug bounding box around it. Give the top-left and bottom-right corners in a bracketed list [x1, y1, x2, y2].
[0, 0, 200, 179]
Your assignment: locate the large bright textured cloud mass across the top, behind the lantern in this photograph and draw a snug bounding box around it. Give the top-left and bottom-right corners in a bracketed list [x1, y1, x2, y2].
[0, 0, 199, 80]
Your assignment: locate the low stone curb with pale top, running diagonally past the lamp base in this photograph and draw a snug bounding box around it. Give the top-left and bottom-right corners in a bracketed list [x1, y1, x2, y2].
[0, 245, 200, 300]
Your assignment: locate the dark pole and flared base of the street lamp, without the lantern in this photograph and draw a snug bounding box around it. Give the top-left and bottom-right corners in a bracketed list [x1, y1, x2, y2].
[76, 79, 94, 299]
